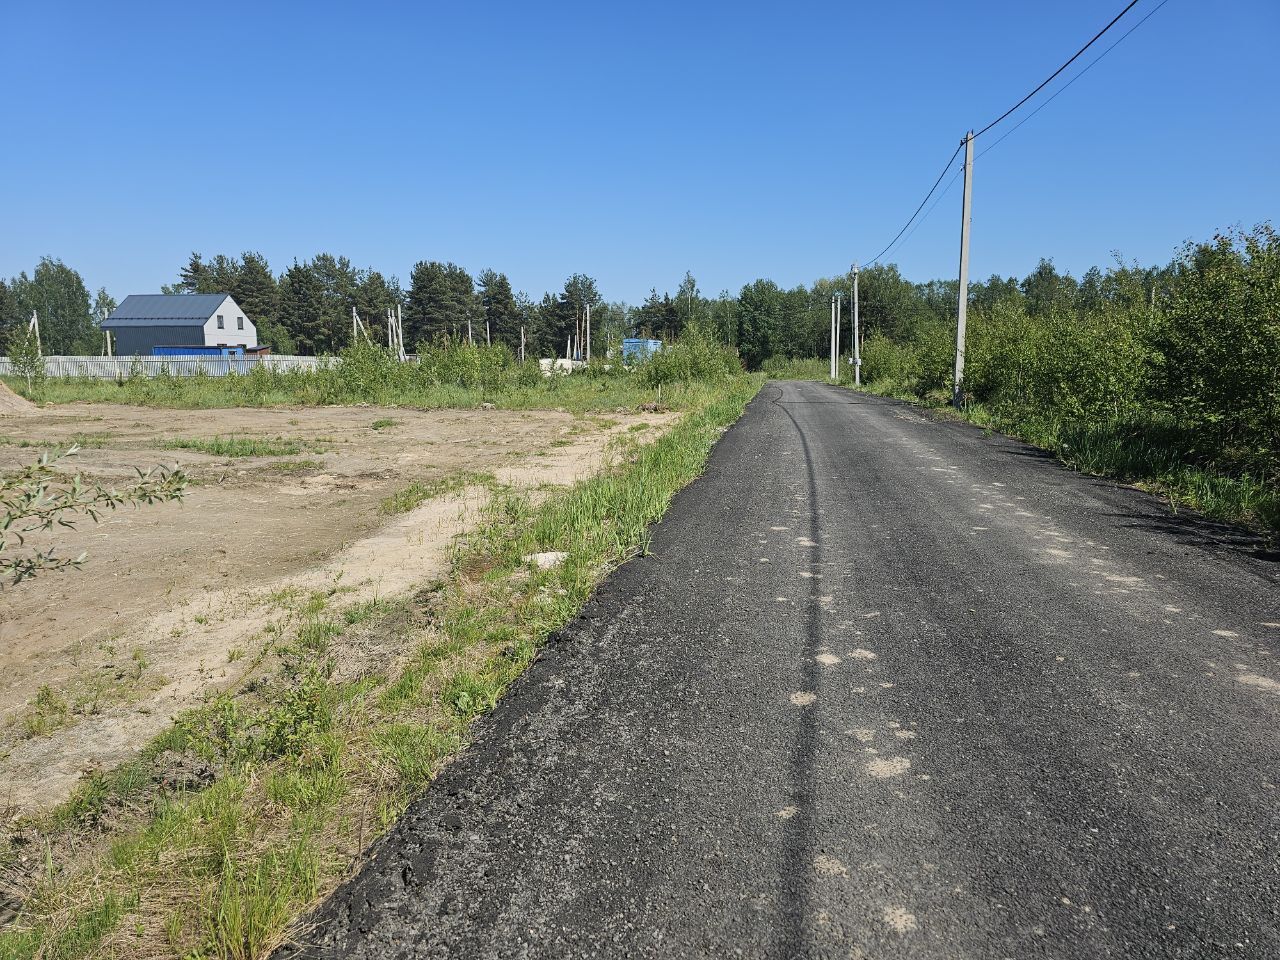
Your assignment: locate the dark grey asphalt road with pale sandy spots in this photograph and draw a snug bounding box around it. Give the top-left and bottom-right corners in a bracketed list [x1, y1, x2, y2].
[293, 383, 1280, 959]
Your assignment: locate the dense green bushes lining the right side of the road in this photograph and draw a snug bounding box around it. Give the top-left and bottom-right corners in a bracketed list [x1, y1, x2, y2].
[863, 225, 1280, 529]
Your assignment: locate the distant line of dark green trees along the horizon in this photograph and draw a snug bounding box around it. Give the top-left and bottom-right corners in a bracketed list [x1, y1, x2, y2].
[0, 227, 1259, 369]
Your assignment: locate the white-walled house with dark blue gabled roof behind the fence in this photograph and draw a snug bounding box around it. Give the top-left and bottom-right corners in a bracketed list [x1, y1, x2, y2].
[102, 293, 259, 357]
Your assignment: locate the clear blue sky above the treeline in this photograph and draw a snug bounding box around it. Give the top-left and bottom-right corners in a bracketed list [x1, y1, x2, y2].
[0, 0, 1280, 302]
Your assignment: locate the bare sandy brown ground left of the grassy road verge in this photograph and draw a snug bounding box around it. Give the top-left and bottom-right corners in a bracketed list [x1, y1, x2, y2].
[0, 404, 672, 812]
